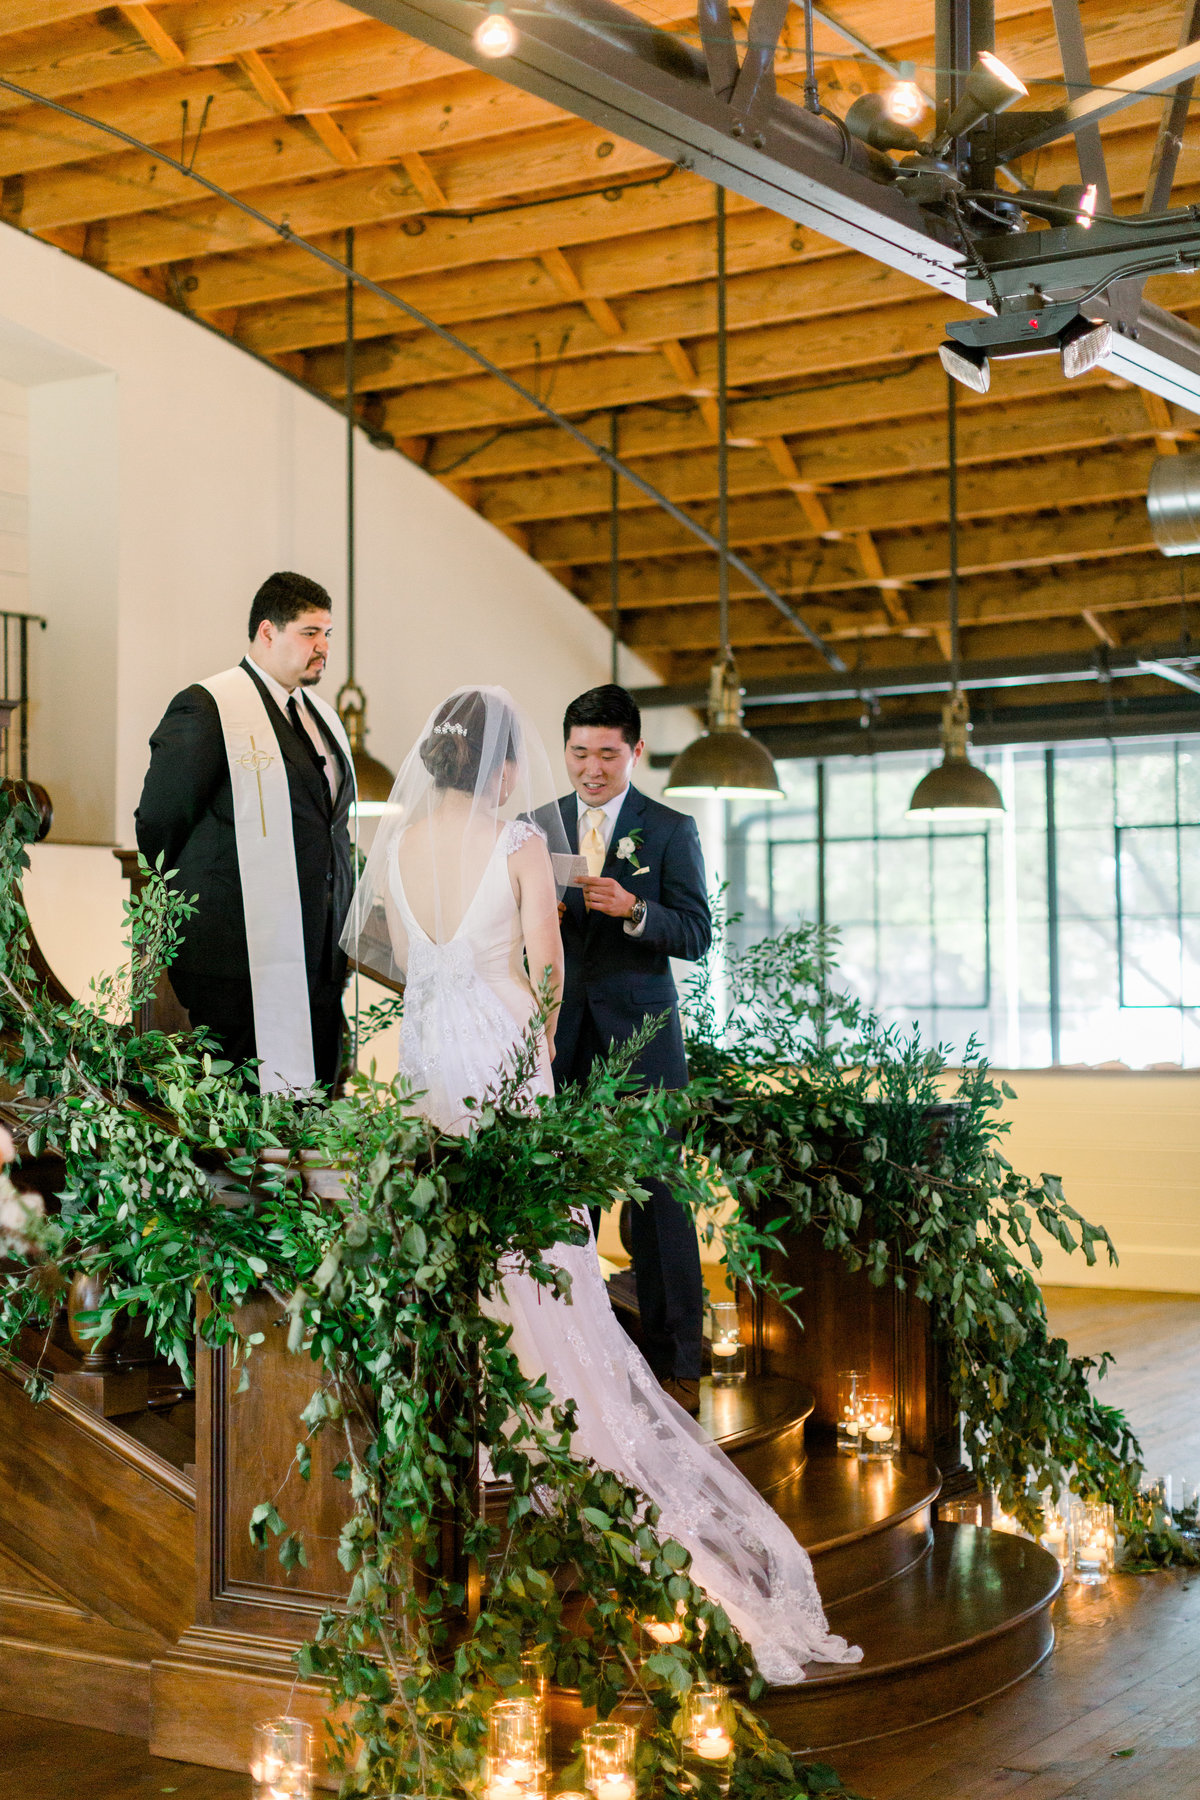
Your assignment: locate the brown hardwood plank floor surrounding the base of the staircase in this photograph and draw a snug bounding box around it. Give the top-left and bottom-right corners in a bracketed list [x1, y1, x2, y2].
[0, 1289, 1200, 1800]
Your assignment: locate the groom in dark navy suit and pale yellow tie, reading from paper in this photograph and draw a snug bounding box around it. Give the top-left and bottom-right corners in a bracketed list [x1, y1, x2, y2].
[554, 686, 712, 1413]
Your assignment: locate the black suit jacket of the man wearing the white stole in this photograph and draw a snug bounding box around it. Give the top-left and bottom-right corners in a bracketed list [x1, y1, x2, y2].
[137, 662, 354, 983]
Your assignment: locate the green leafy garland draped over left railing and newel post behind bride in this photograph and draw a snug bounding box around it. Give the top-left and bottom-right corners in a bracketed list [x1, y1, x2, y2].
[0, 797, 863, 1800]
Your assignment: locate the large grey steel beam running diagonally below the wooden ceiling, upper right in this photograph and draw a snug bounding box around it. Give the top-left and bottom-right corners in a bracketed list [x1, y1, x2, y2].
[358, 0, 1200, 412]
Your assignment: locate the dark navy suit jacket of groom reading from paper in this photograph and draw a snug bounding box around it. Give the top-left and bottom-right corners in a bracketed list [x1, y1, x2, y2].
[554, 787, 712, 1087]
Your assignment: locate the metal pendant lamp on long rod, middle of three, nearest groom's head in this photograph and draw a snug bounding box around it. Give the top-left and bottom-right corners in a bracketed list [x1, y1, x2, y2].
[664, 187, 783, 799]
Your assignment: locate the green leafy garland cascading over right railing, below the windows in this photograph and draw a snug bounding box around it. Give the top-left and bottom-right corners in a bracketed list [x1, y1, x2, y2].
[687, 925, 1146, 1534]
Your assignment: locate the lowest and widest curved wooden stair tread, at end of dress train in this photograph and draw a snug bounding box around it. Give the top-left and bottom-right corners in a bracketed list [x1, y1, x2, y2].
[792, 1525, 1061, 1699]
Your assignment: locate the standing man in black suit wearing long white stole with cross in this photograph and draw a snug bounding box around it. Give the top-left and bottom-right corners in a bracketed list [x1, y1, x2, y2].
[137, 571, 354, 1093]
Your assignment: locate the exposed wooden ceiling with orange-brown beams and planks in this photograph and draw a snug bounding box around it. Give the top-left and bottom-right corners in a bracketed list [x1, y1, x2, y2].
[0, 0, 1200, 745]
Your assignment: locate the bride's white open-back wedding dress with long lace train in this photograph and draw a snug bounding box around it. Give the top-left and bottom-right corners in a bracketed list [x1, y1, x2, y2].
[387, 823, 862, 1685]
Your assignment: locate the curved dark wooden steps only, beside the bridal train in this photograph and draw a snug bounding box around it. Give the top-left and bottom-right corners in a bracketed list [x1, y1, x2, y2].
[700, 1377, 1061, 1751]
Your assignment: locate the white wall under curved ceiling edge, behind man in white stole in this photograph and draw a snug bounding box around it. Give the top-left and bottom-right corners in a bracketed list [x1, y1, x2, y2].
[0, 227, 694, 844]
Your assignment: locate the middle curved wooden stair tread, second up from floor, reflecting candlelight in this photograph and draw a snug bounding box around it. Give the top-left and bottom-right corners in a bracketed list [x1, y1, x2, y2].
[770, 1449, 941, 1557]
